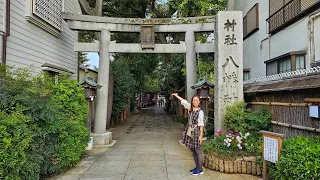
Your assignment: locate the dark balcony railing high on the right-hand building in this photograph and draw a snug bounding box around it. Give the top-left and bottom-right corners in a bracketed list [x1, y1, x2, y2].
[267, 0, 320, 34]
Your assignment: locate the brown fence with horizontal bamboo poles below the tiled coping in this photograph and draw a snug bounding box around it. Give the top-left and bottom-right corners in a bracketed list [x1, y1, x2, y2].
[245, 88, 320, 137]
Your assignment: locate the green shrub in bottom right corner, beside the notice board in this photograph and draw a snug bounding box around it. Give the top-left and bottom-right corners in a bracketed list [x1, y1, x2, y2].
[273, 136, 320, 180]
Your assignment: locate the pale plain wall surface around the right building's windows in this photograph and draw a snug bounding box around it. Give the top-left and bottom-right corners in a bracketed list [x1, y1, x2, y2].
[228, 0, 320, 78]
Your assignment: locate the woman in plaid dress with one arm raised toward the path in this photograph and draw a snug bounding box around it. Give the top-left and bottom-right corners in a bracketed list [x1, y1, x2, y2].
[172, 93, 204, 176]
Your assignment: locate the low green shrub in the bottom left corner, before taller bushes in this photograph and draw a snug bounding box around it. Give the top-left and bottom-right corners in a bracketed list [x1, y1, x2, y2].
[0, 112, 40, 180]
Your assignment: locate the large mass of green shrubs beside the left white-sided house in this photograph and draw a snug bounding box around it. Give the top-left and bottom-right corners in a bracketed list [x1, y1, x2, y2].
[0, 68, 89, 179]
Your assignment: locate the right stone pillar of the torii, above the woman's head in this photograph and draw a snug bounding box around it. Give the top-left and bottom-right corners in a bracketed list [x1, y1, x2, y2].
[185, 31, 197, 103]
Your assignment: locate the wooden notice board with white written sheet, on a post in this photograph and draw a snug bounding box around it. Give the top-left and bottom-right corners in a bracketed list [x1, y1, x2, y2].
[260, 131, 285, 180]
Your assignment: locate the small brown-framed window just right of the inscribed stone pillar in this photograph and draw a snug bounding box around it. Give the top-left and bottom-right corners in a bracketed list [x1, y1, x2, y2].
[243, 3, 259, 39]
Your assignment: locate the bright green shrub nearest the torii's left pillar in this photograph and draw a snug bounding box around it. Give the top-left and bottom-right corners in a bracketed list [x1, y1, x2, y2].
[44, 75, 89, 173]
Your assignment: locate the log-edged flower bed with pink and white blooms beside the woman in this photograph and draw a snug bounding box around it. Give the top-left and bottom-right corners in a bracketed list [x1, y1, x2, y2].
[202, 102, 271, 175]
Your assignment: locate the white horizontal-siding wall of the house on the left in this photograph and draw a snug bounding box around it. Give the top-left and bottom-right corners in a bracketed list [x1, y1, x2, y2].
[5, 0, 79, 79]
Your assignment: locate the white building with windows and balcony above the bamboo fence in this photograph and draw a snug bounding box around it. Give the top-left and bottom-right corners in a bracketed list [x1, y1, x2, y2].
[227, 0, 320, 80]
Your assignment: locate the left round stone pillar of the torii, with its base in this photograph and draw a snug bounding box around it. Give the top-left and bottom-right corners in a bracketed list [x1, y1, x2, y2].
[92, 30, 112, 145]
